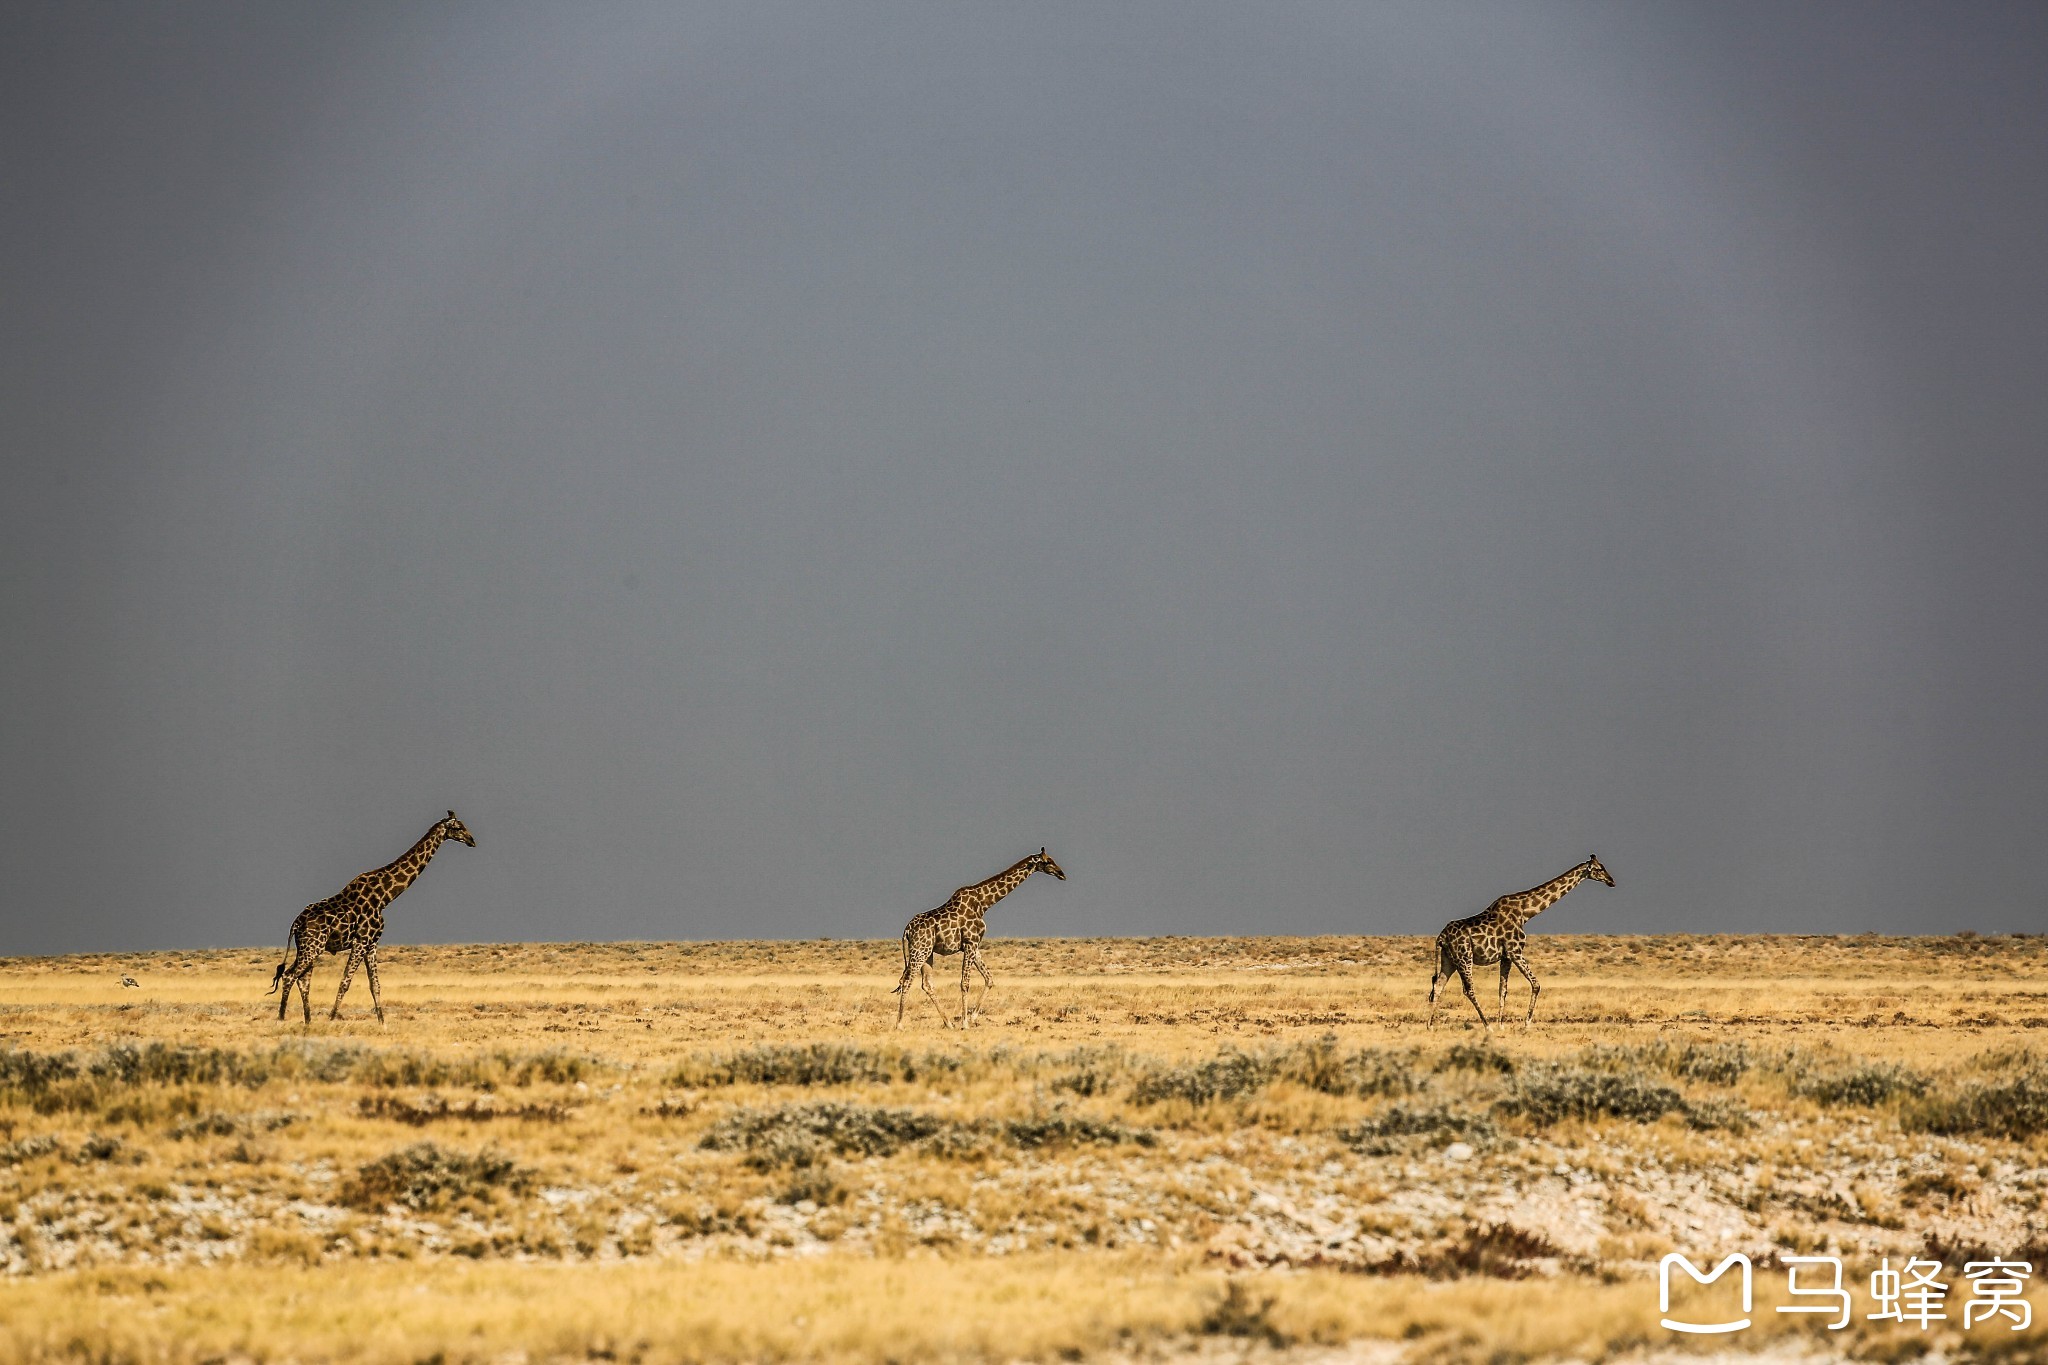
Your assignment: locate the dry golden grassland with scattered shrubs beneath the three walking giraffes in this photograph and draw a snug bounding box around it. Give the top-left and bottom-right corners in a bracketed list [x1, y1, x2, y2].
[0, 935, 2048, 1365]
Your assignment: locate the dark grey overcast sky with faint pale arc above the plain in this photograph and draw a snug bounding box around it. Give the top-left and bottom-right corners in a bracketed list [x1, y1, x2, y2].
[0, 0, 2048, 954]
